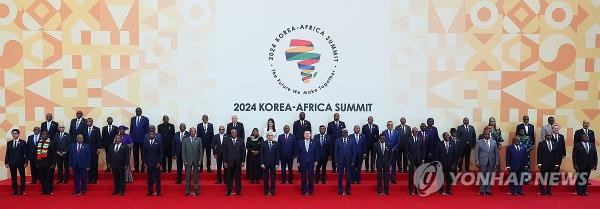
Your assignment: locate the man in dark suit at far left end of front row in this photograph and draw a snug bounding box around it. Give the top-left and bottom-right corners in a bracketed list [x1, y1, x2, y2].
[4, 129, 27, 195]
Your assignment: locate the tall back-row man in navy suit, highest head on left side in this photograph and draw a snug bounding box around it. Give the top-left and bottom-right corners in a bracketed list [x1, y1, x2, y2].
[129, 107, 150, 173]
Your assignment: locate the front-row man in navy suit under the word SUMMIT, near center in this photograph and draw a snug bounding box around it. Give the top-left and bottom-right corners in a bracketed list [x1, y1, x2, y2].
[298, 131, 317, 195]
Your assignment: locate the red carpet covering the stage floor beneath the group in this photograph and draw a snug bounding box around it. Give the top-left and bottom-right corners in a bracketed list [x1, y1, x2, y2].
[0, 173, 600, 209]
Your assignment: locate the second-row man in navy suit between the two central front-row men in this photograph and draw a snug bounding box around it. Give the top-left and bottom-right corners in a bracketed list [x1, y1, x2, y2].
[277, 125, 297, 184]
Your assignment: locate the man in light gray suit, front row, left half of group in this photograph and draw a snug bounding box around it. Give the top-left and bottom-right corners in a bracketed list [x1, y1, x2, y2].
[181, 128, 204, 196]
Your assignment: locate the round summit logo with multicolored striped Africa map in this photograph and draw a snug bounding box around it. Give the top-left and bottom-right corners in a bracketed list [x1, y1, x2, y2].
[268, 25, 339, 95]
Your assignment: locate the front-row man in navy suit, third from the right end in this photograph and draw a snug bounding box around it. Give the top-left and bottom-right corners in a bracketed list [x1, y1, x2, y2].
[506, 136, 527, 195]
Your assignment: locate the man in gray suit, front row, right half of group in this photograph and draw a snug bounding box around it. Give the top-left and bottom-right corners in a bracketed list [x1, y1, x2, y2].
[475, 130, 500, 195]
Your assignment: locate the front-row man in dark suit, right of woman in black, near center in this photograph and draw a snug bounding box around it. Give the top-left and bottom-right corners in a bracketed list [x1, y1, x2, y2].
[260, 132, 279, 196]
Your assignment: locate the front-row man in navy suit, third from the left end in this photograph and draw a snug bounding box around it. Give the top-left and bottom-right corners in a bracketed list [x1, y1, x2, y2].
[69, 134, 92, 195]
